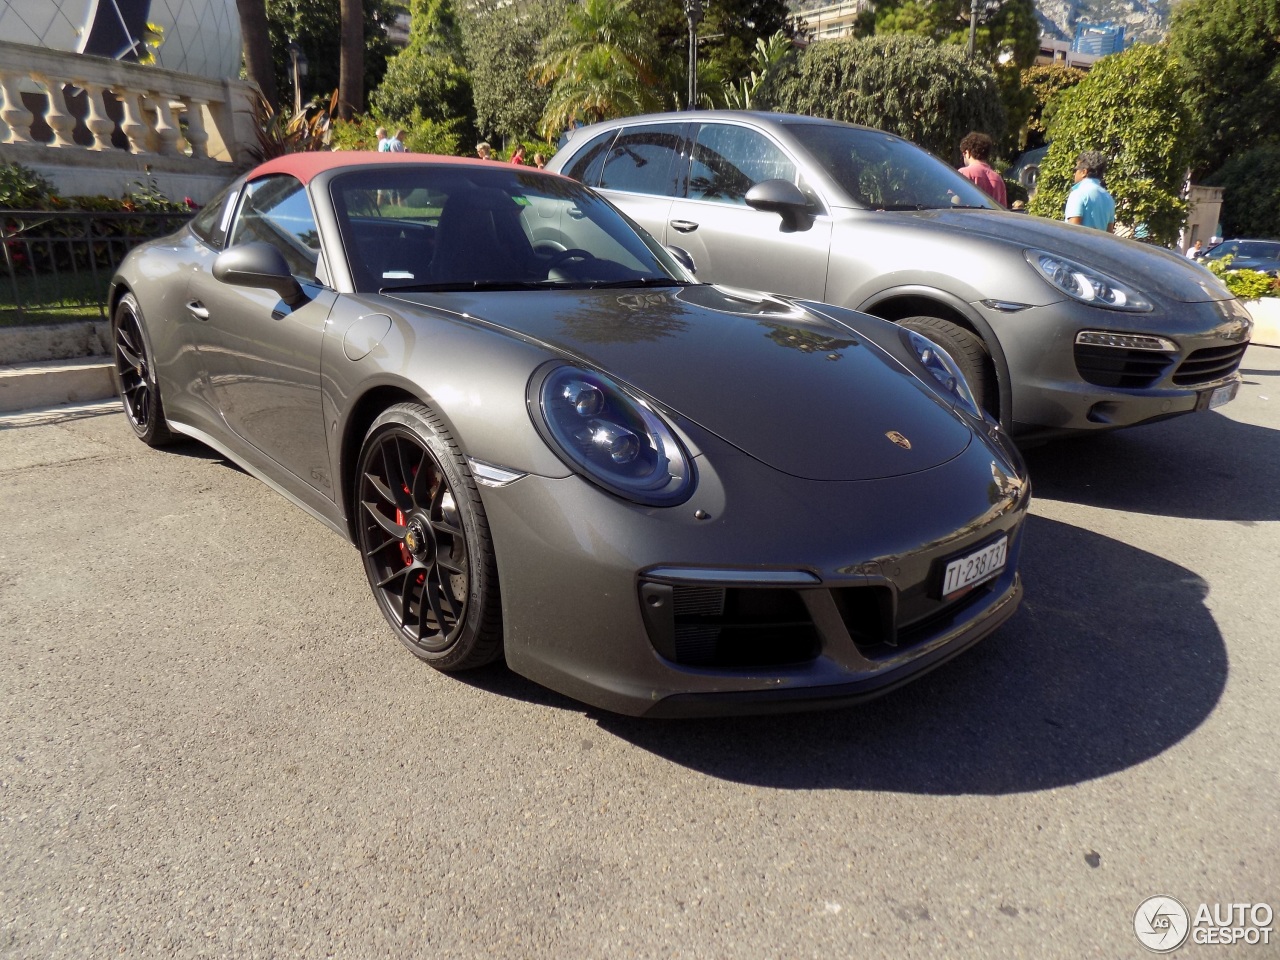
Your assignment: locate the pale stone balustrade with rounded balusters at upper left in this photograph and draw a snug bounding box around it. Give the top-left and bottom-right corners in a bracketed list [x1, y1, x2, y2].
[0, 42, 256, 202]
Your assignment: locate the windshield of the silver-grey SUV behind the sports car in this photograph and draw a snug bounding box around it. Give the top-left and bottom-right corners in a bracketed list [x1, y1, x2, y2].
[786, 123, 998, 210]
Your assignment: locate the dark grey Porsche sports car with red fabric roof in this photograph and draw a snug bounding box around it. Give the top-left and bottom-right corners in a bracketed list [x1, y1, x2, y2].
[110, 152, 1030, 716]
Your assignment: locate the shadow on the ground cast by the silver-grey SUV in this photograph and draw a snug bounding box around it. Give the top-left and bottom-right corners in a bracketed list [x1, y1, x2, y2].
[1025, 407, 1280, 524]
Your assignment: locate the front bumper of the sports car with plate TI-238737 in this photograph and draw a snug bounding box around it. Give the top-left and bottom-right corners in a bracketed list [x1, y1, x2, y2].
[483, 424, 1030, 717]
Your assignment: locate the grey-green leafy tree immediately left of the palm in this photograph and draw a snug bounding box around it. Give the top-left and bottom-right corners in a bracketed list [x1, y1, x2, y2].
[461, 0, 572, 138]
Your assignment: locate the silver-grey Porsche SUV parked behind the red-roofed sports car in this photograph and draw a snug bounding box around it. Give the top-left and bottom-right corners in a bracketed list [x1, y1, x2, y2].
[550, 111, 1251, 436]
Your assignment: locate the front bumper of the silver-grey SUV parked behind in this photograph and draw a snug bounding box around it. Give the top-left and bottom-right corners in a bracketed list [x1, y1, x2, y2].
[974, 300, 1253, 438]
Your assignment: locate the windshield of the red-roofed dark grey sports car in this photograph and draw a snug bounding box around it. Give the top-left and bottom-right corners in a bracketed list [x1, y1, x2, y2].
[330, 164, 690, 292]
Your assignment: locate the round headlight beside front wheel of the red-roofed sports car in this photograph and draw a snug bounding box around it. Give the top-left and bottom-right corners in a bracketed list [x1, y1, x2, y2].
[529, 365, 694, 507]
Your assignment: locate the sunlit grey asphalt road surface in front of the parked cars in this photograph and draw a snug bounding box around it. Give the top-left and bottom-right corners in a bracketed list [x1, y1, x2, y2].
[0, 347, 1280, 960]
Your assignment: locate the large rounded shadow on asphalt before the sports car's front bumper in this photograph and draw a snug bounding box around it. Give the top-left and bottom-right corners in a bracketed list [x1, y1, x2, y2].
[472, 516, 1228, 795]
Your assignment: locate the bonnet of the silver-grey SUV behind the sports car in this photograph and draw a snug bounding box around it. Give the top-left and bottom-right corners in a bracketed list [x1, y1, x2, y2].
[890, 210, 1231, 303]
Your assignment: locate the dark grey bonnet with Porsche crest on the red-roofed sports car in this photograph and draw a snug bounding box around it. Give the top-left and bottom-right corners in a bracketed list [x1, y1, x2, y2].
[397, 285, 973, 480]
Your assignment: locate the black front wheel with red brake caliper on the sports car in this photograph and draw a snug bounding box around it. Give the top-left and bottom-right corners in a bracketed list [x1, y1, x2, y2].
[352, 403, 502, 672]
